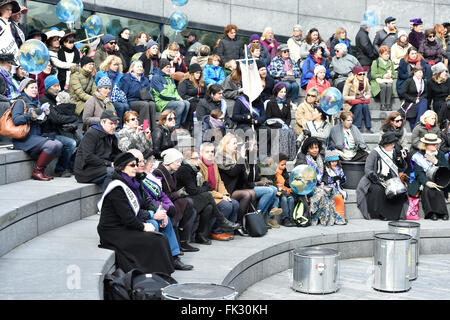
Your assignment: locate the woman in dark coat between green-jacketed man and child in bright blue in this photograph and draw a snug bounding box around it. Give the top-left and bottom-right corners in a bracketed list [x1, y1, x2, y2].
[178, 63, 206, 132]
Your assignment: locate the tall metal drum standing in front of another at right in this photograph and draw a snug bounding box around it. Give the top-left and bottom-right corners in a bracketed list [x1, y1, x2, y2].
[373, 233, 411, 292]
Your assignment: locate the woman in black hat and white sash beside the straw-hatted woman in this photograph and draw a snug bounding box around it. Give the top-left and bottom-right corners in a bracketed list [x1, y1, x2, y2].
[356, 131, 408, 221]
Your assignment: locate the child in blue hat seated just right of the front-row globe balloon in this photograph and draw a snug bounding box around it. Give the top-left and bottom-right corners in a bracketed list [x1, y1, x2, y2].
[322, 150, 347, 224]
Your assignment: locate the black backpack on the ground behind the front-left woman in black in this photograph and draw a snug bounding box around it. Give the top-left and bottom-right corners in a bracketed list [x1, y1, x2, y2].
[103, 268, 178, 300]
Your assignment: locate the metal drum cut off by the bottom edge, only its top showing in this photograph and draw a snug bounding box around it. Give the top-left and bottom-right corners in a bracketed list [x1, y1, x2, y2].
[161, 283, 238, 300]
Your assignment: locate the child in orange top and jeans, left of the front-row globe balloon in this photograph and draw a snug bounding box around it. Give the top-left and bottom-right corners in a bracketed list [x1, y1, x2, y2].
[275, 153, 297, 227]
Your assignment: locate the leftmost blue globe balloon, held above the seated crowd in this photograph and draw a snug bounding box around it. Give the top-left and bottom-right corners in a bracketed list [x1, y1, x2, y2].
[19, 39, 50, 74]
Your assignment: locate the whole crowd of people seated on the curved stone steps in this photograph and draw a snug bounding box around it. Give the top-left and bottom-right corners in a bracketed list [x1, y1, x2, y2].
[0, 1, 450, 273]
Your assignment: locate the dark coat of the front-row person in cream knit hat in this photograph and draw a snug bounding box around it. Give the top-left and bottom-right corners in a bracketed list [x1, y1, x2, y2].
[153, 162, 188, 221]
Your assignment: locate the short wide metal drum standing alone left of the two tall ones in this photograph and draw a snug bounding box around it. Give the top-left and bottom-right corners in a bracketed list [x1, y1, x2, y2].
[291, 247, 340, 294]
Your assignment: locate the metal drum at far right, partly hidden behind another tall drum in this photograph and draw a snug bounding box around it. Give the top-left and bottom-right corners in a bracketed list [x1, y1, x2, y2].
[388, 221, 420, 280]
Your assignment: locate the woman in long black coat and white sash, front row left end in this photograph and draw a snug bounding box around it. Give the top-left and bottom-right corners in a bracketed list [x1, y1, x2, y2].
[97, 153, 175, 274]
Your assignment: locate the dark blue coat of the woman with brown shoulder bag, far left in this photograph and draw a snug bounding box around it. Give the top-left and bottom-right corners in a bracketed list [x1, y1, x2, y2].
[12, 93, 47, 151]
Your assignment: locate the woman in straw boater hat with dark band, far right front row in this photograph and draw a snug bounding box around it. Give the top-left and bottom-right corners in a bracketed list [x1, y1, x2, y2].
[407, 133, 450, 221]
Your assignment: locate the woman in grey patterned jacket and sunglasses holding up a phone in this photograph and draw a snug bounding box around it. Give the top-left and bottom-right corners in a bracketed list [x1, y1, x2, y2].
[117, 111, 153, 159]
